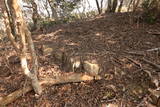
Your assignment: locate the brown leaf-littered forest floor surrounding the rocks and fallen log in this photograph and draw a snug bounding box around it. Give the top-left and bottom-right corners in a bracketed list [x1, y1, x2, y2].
[0, 13, 160, 107]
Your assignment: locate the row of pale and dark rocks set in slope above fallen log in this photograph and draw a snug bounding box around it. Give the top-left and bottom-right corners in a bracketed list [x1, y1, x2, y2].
[42, 45, 102, 78]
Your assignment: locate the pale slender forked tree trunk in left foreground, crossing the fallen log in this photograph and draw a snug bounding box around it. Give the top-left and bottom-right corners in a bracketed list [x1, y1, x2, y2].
[8, 0, 42, 94]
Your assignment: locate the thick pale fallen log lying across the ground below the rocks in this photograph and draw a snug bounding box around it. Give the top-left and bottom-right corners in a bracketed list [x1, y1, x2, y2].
[0, 73, 94, 106]
